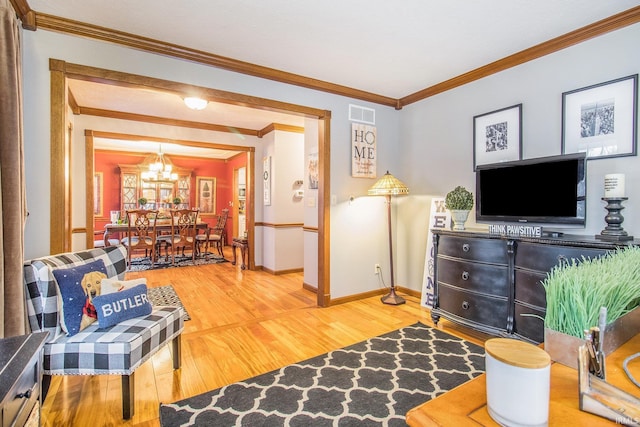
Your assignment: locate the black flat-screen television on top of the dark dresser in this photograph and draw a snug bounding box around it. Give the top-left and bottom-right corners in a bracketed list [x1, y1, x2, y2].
[476, 153, 587, 226]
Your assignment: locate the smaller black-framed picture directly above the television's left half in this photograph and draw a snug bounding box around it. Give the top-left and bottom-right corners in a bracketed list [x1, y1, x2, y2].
[473, 104, 522, 172]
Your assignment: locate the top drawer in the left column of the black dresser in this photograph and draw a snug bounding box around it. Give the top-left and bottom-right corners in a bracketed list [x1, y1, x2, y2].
[438, 236, 509, 265]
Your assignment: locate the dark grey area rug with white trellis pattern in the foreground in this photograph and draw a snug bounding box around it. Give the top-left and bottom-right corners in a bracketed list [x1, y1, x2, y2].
[160, 323, 484, 427]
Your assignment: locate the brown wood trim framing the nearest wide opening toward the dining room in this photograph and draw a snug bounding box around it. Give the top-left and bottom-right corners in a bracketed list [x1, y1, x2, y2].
[49, 59, 331, 307]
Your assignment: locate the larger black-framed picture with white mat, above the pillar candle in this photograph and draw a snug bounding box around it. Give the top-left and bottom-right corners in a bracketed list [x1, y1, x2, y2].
[562, 74, 638, 159]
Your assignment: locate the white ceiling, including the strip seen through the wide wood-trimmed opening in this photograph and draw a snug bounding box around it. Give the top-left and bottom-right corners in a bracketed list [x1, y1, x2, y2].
[28, 0, 640, 156]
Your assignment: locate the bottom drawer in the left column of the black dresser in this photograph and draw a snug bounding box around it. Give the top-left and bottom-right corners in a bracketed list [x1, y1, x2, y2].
[438, 284, 509, 330]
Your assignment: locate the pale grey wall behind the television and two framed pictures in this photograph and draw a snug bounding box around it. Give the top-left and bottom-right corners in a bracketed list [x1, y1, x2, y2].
[398, 24, 640, 289]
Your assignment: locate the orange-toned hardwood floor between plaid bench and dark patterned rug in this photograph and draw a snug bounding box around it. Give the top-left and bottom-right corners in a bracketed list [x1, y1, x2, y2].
[41, 252, 487, 427]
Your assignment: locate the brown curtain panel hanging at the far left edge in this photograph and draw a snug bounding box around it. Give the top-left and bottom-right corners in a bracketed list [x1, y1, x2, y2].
[0, 0, 26, 337]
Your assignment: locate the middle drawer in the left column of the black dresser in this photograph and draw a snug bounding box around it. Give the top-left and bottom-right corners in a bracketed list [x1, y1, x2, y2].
[437, 258, 509, 297]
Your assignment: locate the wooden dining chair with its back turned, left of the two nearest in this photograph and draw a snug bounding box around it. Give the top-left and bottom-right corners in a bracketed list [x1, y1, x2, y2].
[120, 209, 158, 267]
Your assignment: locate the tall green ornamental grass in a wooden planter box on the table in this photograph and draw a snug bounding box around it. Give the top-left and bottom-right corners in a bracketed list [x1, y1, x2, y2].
[542, 246, 640, 368]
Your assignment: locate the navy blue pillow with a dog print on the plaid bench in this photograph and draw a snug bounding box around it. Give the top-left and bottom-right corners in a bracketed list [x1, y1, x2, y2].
[52, 259, 107, 336]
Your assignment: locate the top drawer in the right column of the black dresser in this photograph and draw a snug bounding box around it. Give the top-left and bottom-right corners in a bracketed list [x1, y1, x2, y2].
[515, 242, 607, 272]
